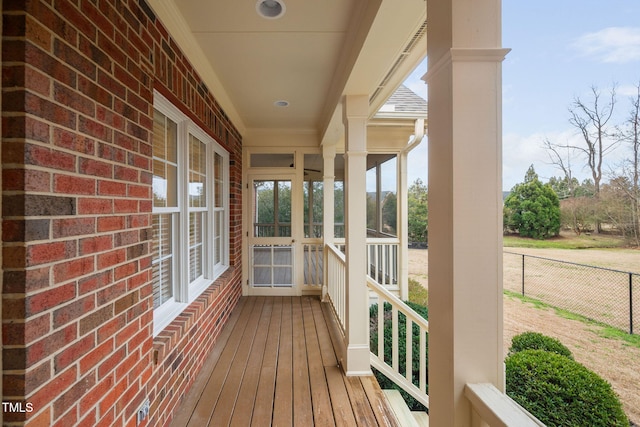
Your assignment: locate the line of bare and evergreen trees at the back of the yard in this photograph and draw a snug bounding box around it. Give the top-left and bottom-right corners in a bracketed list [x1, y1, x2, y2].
[504, 84, 640, 246]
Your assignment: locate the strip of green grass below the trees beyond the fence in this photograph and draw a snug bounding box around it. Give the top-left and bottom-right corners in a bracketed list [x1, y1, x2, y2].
[503, 233, 625, 249]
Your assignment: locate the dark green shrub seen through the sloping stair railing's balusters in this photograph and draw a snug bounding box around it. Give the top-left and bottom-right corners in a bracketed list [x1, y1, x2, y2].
[369, 301, 429, 412]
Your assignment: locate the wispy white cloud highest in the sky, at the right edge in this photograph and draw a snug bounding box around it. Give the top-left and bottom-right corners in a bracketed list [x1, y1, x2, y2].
[572, 27, 640, 64]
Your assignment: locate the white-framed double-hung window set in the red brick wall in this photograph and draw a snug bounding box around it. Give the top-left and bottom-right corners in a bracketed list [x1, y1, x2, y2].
[152, 93, 229, 334]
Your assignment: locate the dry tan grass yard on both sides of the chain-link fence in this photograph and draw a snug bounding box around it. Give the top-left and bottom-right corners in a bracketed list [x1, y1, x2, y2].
[409, 244, 640, 425]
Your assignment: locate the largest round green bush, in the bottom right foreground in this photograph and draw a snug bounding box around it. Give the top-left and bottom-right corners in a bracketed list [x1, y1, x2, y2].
[505, 350, 629, 427]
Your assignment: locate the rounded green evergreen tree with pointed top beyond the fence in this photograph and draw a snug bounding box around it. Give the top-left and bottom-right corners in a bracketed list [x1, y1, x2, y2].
[503, 165, 560, 239]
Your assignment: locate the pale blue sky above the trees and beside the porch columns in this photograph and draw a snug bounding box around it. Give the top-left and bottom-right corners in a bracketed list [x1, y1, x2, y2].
[407, 0, 640, 190]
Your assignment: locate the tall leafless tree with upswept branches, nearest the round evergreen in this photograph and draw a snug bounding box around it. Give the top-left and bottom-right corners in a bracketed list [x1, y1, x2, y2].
[569, 85, 619, 232]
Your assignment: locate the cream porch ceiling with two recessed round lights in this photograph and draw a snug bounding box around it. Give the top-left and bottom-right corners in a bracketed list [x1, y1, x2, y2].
[149, 0, 426, 143]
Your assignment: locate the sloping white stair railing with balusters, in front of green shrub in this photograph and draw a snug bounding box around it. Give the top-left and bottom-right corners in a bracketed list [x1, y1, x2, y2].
[367, 276, 429, 407]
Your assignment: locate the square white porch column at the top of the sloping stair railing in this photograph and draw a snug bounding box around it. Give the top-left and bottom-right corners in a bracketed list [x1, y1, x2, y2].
[343, 95, 371, 375]
